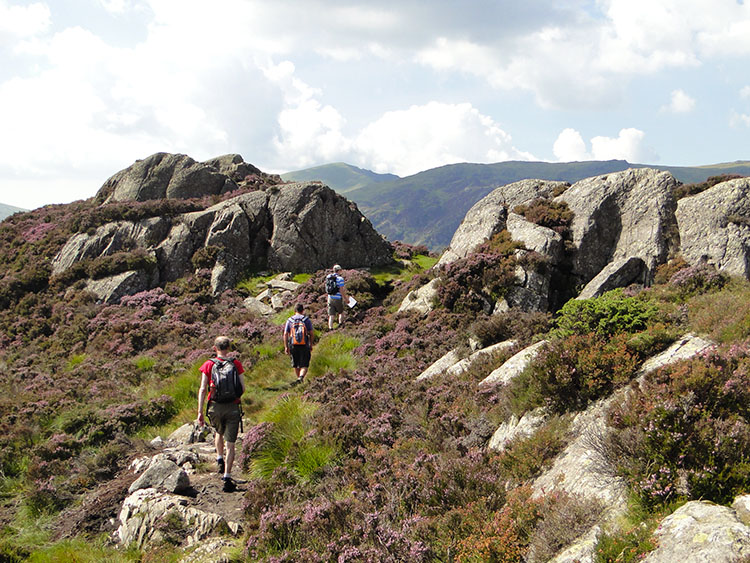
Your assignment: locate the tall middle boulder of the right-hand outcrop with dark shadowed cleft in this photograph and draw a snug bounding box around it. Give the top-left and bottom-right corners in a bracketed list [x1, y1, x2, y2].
[556, 168, 678, 283]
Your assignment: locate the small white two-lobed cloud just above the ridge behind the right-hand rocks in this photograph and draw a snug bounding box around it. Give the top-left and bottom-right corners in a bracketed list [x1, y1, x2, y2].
[553, 128, 658, 163]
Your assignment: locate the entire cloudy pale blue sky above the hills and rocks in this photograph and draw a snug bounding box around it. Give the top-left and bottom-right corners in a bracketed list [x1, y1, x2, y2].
[0, 0, 750, 209]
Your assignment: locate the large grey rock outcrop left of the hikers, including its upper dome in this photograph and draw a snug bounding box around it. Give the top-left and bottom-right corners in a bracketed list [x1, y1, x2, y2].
[52, 154, 393, 302]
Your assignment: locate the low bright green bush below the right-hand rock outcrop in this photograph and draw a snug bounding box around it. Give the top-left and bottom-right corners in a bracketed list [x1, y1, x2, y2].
[556, 289, 661, 338]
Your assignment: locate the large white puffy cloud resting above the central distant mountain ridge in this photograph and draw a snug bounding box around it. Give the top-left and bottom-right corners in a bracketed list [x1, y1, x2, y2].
[354, 102, 534, 176]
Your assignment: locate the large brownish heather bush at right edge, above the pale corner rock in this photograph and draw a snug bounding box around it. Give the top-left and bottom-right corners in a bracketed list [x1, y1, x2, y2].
[605, 345, 750, 507]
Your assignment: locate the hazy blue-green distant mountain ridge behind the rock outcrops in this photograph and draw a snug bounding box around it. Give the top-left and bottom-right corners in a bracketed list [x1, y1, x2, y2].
[281, 160, 750, 250]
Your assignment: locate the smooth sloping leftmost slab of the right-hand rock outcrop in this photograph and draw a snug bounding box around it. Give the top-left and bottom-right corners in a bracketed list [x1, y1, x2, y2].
[437, 180, 568, 266]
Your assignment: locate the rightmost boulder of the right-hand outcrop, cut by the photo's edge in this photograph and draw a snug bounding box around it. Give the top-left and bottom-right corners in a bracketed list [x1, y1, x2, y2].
[677, 178, 750, 278]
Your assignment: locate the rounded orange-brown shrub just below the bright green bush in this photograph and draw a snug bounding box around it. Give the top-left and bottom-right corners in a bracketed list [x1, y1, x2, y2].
[526, 334, 638, 413]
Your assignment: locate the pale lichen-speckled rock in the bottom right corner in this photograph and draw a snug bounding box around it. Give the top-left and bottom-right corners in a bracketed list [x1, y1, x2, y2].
[643, 501, 750, 563]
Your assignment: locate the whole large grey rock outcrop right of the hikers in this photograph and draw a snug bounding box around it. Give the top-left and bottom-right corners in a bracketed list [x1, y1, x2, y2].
[438, 168, 750, 318]
